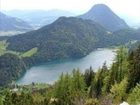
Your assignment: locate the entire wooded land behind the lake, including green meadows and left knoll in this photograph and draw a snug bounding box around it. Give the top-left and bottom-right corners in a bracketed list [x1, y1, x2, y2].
[0, 17, 140, 85]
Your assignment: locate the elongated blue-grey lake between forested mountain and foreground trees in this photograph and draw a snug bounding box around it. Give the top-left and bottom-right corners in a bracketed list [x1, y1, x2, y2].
[16, 49, 116, 85]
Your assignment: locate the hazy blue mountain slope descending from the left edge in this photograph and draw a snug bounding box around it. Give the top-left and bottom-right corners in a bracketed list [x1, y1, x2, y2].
[0, 12, 32, 31]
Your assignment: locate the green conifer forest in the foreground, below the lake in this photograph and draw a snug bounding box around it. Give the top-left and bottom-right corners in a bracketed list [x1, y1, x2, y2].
[0, 46, 140, 105]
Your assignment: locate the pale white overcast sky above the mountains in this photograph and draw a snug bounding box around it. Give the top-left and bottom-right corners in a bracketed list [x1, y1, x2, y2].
[0, 0, 140, 24]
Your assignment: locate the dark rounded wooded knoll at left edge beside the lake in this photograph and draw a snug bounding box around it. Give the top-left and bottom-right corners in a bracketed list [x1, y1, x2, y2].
[0, 54, 27, 86]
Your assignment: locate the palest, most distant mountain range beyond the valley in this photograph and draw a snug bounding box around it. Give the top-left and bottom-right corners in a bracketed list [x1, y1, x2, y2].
[5, 10, 74, 28]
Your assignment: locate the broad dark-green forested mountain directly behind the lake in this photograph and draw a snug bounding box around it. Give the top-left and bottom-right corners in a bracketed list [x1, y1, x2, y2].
[7, 17, 111, 62]
